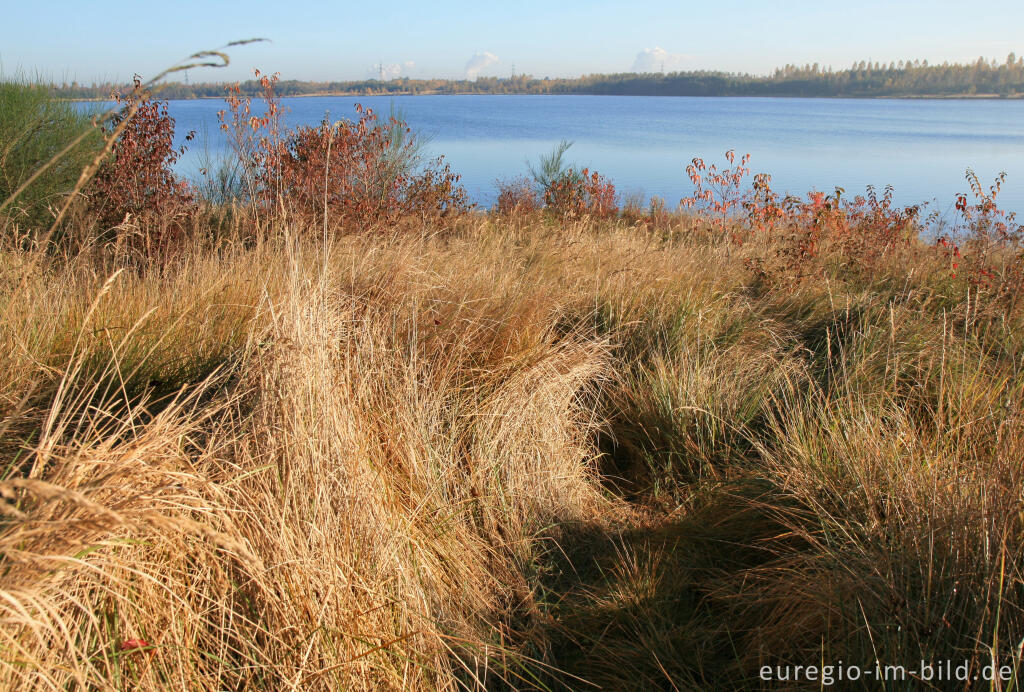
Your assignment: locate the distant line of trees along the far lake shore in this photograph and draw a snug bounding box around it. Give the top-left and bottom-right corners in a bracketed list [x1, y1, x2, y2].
[52, 53, 1024, 99]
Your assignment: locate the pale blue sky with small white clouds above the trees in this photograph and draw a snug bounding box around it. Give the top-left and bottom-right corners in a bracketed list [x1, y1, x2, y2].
[0, 0, 1024, 83]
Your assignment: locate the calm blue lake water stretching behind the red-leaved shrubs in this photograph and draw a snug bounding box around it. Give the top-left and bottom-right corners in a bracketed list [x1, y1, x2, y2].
[114, 96, 1024, 212]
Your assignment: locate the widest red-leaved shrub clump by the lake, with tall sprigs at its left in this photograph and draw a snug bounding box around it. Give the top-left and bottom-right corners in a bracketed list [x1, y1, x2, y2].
[218, 72, 471, 229]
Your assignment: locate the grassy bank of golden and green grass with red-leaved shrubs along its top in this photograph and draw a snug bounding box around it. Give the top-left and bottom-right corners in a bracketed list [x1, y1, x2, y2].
[6, 80, 1024, 690]
